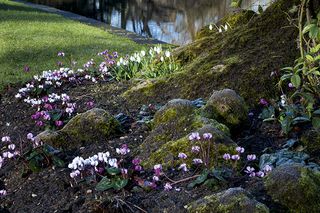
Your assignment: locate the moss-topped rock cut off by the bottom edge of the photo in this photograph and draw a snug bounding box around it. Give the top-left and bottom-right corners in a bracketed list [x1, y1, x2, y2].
[185, 187, 269, 213]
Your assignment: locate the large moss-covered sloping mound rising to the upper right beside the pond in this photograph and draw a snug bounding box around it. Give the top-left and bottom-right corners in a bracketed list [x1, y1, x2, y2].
[125, 0, 299, 105]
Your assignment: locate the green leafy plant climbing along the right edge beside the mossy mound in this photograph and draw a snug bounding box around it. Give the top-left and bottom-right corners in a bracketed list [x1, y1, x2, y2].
[260, 3, 320, 134]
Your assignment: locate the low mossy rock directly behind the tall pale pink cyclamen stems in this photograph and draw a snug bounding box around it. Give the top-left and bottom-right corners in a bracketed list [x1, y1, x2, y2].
[143, 124, 236, 168]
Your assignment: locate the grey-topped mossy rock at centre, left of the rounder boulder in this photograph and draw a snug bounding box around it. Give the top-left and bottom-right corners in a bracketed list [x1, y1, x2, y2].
[136, 99, 230, 164]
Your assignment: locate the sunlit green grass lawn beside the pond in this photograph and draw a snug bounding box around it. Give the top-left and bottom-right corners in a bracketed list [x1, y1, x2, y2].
[0, 0, 142, 91]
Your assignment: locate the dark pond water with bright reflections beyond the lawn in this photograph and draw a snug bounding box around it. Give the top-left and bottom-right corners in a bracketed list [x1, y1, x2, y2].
[29, 0, 272, 45]
